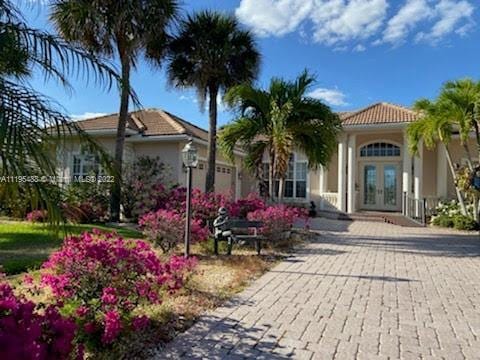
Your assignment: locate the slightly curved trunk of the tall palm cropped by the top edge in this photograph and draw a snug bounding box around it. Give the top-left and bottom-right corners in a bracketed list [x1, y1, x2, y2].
[110, 46, 130, 222]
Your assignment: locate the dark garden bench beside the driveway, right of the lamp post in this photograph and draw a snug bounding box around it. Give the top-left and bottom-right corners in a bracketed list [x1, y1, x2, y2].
[214, 219, 264, 255]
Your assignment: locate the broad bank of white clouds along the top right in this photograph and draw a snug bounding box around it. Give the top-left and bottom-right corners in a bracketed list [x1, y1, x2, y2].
[236, 0, 474, 51]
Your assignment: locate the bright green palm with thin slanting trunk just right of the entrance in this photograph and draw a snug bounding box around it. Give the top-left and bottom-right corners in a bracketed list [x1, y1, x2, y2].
[407, 99, 467, 215]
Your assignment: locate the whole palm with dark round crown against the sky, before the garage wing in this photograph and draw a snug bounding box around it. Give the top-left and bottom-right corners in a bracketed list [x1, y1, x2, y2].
[168, 11, 260, 192]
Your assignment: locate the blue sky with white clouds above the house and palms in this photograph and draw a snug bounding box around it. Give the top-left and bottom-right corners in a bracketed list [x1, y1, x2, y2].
[18, 0, 480, 128]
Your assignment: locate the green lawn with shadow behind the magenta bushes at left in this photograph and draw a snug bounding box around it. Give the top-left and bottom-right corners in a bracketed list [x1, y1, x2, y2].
[0, 220, 142, 275]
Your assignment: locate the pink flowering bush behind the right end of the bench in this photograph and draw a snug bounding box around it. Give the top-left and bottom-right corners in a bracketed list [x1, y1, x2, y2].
[247, 205, 308, 240]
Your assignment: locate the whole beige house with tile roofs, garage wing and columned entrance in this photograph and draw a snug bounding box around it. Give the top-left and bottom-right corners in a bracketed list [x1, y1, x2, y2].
[62, 102, 474, 213]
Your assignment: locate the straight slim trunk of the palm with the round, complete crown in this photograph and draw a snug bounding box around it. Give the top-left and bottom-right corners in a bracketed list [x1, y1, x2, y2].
[205, 85, 218, 193]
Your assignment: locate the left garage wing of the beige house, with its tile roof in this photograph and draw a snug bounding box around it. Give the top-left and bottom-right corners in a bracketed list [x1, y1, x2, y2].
[59, 109, 255, 198]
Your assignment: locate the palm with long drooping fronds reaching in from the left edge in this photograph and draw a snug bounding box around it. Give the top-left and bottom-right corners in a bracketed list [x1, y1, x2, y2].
[0, 0, 118, 223]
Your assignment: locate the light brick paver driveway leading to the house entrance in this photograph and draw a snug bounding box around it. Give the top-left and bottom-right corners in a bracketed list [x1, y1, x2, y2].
[159, 219, 480, 360]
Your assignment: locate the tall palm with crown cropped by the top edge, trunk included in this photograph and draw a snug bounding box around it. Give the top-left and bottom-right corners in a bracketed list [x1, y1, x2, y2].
[51, 0, 179, 221]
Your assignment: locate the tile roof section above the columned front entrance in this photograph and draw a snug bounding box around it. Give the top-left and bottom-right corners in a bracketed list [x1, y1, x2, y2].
[339, 102, 417, 126]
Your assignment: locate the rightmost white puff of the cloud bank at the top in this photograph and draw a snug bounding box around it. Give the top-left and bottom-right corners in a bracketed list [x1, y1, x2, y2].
[415, 0, 474, 45]
